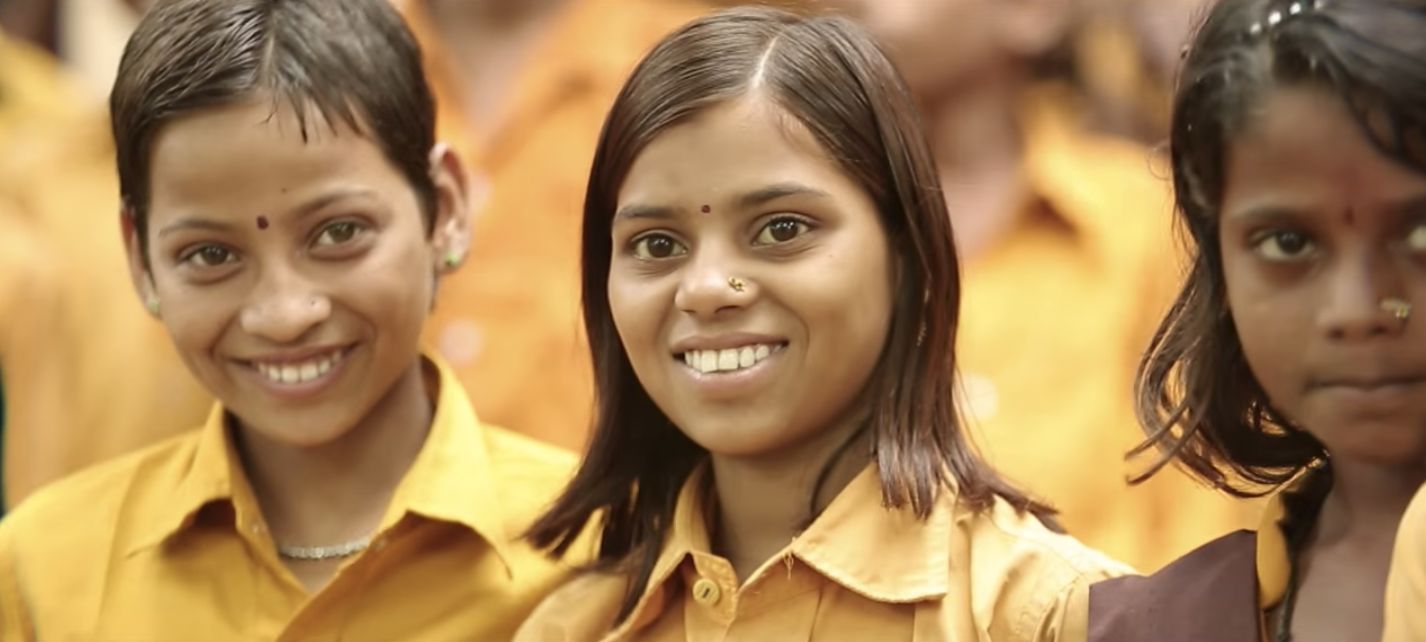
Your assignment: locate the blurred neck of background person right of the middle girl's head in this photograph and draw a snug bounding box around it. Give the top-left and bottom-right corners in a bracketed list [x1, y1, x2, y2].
[921, 68, 1027, 258]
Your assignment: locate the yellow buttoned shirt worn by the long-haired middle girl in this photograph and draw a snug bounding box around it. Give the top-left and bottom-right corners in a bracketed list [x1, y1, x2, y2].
[515, 465, 1128, 642]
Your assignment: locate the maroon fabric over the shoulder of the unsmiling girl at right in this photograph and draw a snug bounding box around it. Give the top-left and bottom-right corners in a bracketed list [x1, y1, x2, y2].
[1089, 531, 1259, 642]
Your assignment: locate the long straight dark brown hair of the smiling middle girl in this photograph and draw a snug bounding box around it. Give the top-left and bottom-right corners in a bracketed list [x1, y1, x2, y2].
[529, 2, 1048, 619]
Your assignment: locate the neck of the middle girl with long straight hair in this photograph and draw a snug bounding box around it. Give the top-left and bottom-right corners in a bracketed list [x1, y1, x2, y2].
[712, 417, 870, 581]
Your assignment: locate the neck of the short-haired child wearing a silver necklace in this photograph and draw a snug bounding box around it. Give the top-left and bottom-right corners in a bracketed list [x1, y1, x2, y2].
[235, 361, 432, 546]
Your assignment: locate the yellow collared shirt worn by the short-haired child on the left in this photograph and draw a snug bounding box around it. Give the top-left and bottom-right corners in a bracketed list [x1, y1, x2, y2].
[0, 356, 573, 642]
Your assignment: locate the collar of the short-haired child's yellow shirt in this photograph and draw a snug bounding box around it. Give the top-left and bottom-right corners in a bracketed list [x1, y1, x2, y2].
[130, 355, 518, 572]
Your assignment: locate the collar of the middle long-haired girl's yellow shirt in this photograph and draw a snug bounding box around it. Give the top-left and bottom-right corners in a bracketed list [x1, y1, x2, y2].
[627, 464, 961, 629]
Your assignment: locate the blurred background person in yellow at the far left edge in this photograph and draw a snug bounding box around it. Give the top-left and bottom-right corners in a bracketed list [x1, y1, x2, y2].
[0, 0, 211, 505]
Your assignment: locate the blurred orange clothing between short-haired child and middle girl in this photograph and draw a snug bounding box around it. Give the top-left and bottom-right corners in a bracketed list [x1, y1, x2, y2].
[401, 0, 706, 449]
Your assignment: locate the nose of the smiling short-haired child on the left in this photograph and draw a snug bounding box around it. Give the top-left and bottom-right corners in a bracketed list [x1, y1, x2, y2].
[240, 270, 332, 344]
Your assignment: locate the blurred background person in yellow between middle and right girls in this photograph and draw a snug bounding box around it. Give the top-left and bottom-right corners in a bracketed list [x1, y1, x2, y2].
[826, 0, 1253, 569]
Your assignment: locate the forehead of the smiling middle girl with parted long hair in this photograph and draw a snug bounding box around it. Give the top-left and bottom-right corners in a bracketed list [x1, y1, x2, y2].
[619, 98, 861, 205]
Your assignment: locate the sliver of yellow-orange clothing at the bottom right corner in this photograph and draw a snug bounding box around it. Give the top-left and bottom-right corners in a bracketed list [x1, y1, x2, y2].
[1382, 486, 1426, 642]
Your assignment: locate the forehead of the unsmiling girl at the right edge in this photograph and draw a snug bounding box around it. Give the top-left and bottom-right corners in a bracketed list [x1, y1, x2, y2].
[1224, 86, 1426, 215]
